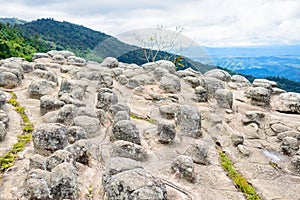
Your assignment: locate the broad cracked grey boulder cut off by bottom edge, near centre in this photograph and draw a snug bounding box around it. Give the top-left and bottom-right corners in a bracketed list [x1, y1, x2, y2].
[104, 168, 167, 200]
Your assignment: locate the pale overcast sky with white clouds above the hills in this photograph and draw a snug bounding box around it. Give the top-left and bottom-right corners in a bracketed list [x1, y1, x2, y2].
[0, 0, 300, 46]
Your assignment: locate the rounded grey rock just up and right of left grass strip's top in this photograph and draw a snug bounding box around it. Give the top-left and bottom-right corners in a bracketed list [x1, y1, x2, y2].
[27, 80, 56, 99]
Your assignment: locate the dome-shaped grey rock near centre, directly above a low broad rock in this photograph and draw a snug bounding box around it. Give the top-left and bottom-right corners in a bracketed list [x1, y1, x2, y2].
[110, 120, 141, 145]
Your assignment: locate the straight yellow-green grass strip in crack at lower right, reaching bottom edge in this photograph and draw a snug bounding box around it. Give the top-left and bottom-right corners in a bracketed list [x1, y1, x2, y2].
[219, 152, 261, 200]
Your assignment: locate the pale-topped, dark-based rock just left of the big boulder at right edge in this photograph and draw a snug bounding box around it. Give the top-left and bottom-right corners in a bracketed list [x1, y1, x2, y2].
[245, 87, 270, 106]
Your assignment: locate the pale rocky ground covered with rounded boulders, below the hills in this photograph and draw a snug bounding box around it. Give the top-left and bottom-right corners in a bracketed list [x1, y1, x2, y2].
[0, 51, 300, 200]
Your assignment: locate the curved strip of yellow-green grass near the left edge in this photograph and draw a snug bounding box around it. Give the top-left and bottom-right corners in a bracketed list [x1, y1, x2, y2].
[0, 92, 34, 171]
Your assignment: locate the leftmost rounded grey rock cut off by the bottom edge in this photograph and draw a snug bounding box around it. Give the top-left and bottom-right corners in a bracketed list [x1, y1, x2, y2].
[24, 169, 53, 200]
